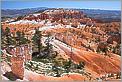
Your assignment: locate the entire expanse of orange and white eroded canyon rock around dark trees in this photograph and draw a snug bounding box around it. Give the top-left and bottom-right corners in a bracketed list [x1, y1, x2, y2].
[2, 9, 121, 81]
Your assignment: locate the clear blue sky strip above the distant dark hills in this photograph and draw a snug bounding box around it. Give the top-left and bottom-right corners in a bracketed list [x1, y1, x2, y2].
[1, 0, 121, 10]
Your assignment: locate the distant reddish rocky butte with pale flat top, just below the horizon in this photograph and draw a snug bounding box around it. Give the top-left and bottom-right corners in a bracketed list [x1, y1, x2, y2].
[23, 9, 94, 27]
